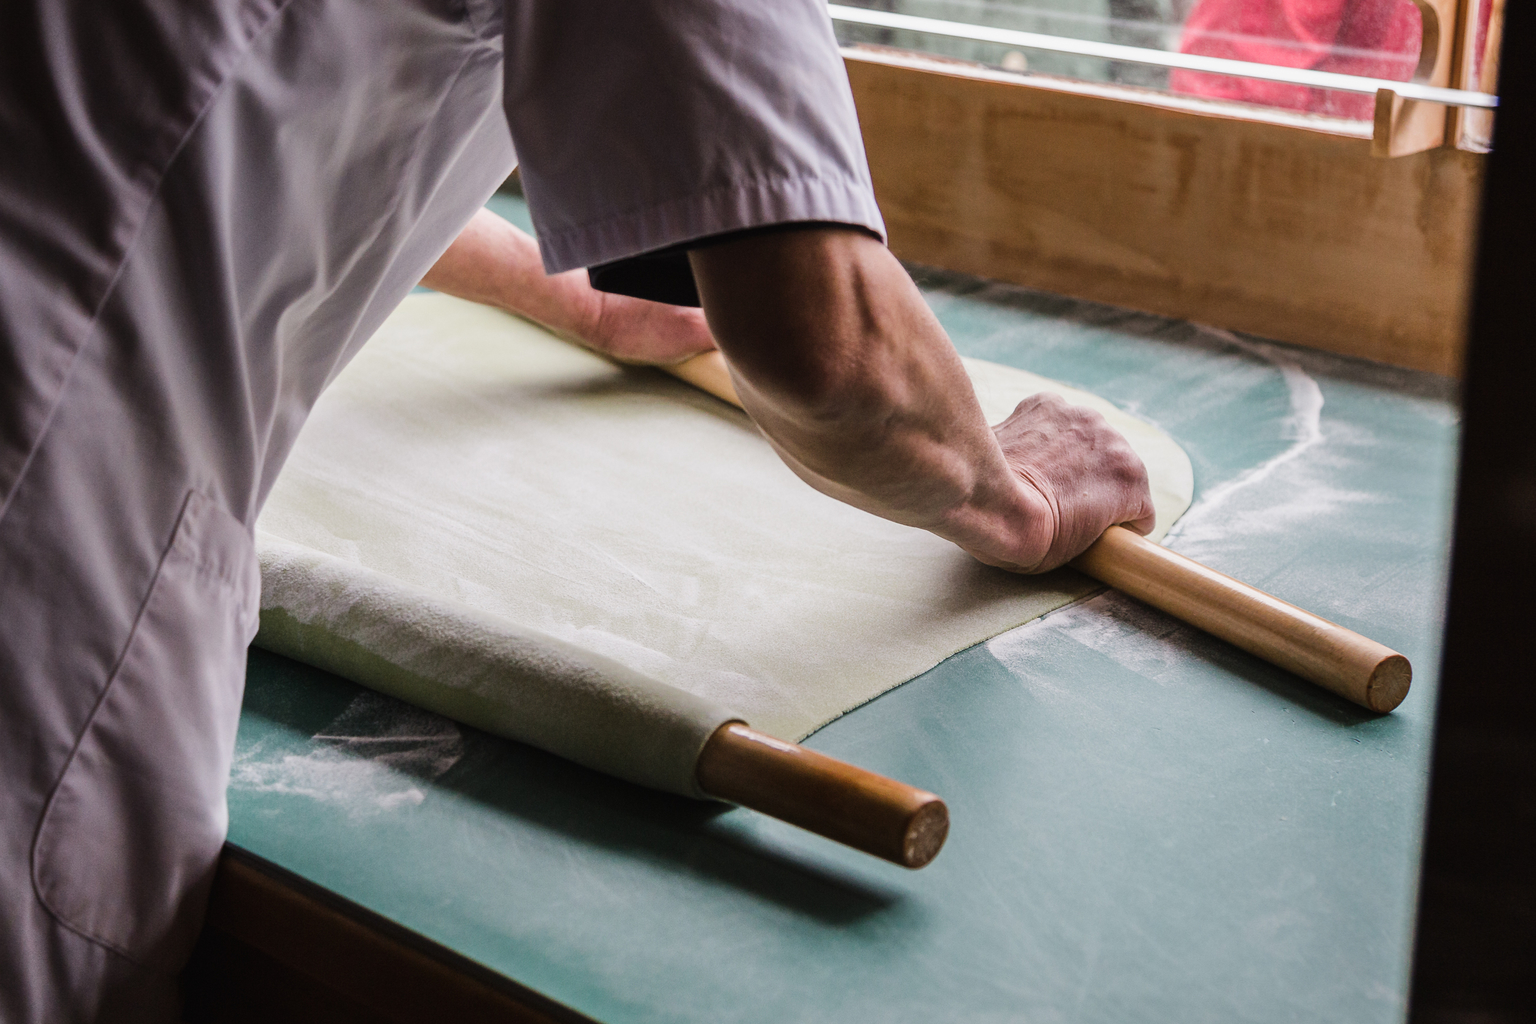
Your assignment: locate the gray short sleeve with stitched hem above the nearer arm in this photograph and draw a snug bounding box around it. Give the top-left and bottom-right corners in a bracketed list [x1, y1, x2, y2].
[504, 0, 885, 273]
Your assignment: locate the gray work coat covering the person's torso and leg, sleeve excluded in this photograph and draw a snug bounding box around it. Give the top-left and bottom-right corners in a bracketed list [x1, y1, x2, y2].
[0, 0, 515, 1024]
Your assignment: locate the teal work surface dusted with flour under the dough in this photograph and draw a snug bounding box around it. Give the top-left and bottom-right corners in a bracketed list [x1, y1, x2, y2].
[229, 211, 1456, 1024]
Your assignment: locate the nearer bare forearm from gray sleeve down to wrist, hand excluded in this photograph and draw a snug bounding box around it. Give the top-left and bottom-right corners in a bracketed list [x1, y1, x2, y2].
[693, 229, 1049, 568]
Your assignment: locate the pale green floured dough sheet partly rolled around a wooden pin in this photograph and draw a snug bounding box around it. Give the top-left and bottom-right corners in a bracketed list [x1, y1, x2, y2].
[257, 295, 1192, 795]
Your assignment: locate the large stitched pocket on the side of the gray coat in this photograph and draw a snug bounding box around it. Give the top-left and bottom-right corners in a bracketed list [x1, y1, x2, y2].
[32, 491, 261, 969]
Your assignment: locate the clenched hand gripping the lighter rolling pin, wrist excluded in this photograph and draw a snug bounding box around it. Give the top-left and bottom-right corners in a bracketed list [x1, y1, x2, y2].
[995, 393, 1157, 573]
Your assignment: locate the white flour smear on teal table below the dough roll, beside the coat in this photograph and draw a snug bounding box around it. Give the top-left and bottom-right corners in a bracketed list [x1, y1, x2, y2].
[229, 692, 464, 815]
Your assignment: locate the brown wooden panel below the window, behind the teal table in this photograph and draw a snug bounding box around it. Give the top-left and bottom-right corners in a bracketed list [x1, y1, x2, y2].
[848, 57, 1485, 375]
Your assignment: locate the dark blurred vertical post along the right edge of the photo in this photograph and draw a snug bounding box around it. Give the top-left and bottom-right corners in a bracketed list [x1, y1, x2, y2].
[1410, 3, 1536, 1024]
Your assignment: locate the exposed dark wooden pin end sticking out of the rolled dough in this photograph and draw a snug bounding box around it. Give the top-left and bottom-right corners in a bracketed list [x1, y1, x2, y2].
[694, 722, 949, 867]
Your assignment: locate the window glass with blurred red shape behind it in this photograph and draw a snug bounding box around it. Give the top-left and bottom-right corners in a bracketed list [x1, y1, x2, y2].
[837, 0, 1425, 121]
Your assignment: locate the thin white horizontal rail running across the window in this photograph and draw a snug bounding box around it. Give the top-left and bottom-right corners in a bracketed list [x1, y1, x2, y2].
[828, 3, 1499, 109]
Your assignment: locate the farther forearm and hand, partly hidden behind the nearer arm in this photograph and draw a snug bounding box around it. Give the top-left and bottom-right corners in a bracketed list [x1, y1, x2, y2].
[421, 210, 714, 364]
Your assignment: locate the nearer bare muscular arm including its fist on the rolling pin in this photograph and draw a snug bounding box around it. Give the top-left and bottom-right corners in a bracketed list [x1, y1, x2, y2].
[690, 227, 1152, 573]
